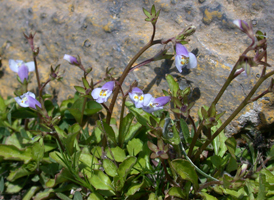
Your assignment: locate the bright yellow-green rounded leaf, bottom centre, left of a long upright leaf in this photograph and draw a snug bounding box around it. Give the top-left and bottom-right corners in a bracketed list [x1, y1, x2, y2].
[89, 170, 113, 192]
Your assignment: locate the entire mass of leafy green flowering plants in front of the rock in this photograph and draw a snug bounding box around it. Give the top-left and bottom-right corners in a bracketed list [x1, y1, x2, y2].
[0, 6, 274, 200]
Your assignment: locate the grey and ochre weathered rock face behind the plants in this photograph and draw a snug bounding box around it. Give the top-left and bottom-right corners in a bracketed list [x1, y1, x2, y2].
[0, 0, 274, 125]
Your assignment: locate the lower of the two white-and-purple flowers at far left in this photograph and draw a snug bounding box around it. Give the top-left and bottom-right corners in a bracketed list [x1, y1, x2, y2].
[14, 92, 41, 109]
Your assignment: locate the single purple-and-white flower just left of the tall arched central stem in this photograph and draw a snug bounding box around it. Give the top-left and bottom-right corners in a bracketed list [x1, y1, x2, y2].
[91, 81, 115, 103]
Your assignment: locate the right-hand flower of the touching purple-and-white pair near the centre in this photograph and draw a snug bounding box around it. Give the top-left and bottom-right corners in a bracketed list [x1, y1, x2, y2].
[142, 94, 171, 113]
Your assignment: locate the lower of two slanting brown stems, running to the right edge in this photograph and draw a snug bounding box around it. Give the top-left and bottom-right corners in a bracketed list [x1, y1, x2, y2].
[193, 71, 274, 161]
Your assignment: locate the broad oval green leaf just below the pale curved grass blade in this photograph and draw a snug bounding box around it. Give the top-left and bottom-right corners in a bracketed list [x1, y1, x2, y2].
[171, 159, 199, 190]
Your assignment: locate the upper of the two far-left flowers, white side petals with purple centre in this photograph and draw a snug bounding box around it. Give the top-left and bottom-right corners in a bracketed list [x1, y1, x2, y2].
[9, 59, 35, 82]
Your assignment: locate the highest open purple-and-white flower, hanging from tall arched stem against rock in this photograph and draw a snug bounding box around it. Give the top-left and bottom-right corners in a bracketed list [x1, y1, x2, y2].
[175, 43, 197, 73]
